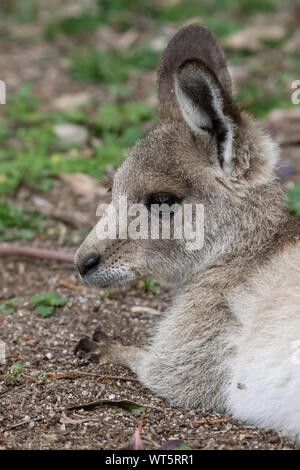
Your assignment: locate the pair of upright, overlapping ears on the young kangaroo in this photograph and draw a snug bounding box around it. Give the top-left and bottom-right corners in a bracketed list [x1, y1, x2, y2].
[158, 24, 240, 172]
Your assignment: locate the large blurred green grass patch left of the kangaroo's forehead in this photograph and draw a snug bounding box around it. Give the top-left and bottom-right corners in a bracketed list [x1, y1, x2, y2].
[0, 84, 154, 196]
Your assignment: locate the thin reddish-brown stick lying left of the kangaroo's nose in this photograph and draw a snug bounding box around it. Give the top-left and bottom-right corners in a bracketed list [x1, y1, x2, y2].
[0, 243, 74, 263]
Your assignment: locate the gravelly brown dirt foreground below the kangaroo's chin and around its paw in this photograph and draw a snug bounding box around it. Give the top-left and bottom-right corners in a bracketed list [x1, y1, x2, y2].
[0, 260, 294, 449]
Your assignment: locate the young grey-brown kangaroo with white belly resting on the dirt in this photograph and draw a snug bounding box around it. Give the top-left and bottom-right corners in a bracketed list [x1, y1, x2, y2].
[75, 24, 300, 440]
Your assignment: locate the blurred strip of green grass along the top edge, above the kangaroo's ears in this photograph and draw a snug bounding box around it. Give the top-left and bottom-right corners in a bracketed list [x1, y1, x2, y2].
[42, 0, 280, 40]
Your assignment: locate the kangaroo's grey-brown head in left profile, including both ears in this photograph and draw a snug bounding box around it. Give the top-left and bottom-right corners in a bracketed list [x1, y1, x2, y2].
[75, 24, 277, 287]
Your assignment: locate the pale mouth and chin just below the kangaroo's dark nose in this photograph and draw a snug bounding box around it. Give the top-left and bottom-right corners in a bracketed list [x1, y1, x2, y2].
[80, 267, 135, 289]
